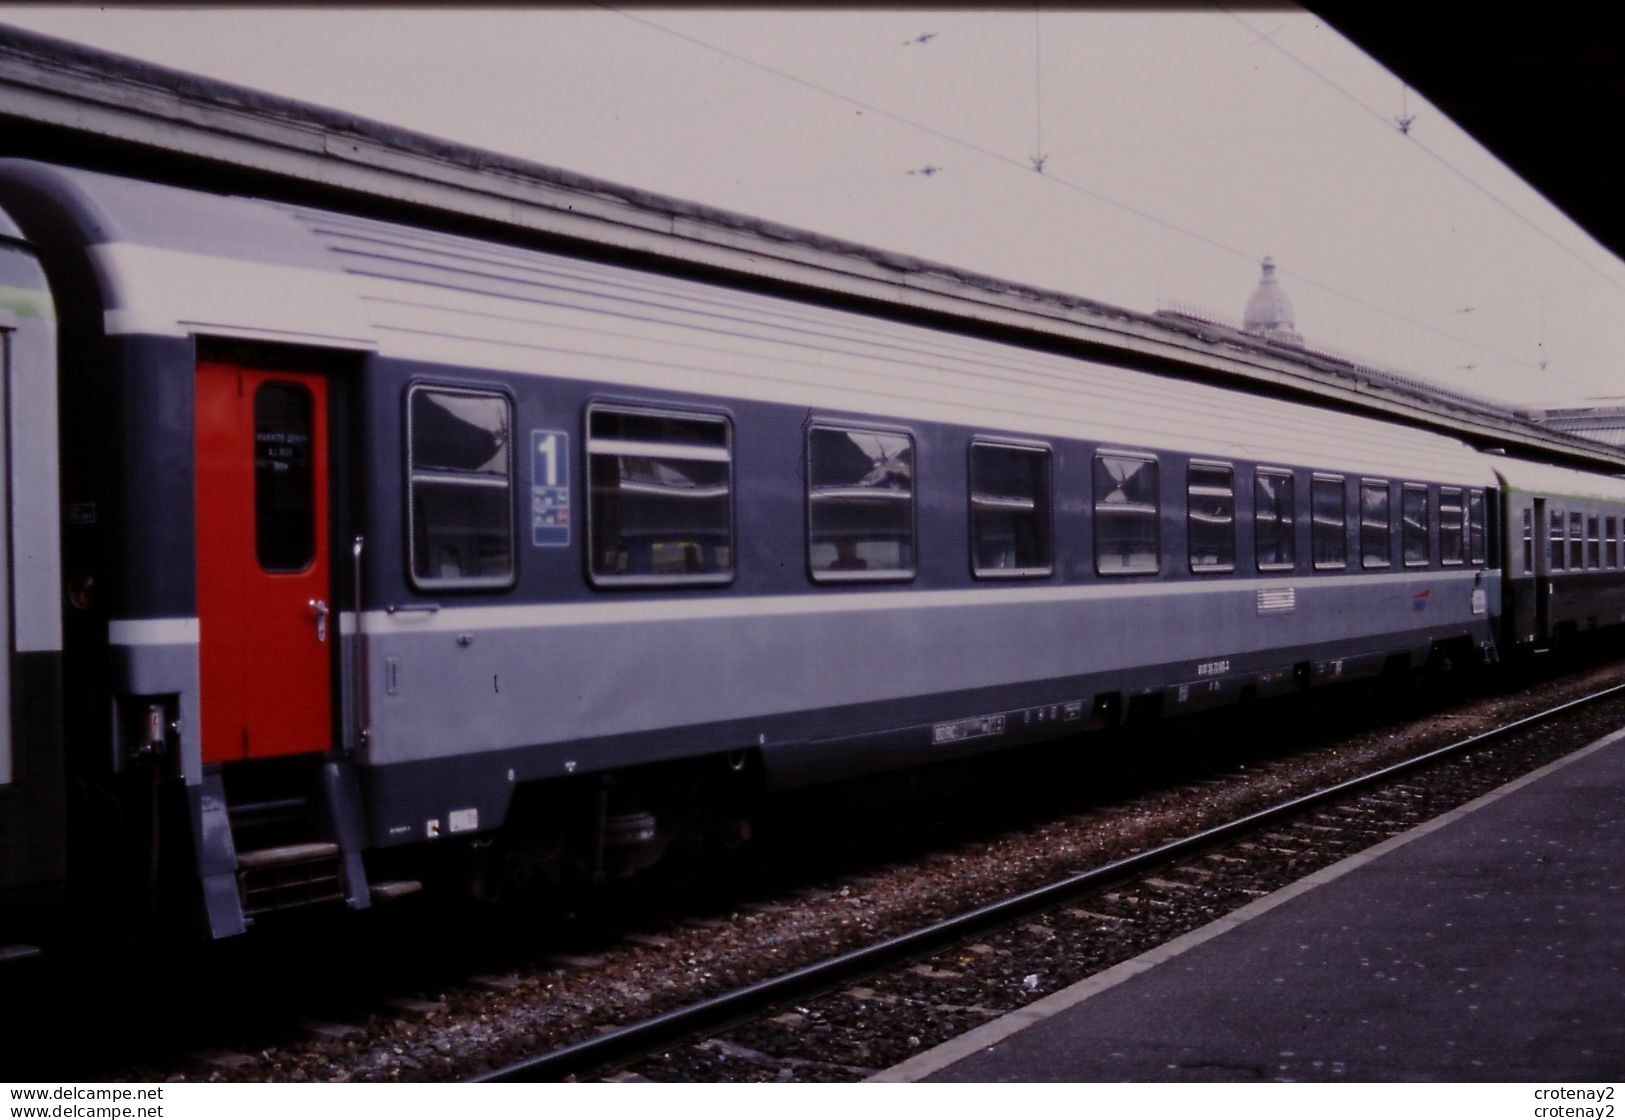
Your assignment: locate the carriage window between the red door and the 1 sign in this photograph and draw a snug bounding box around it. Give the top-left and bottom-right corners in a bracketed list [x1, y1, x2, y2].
[408, 387, 514, 587]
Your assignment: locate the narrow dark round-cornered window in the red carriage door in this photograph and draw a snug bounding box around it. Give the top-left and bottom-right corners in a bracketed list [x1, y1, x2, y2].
[254, 380, 315, 572]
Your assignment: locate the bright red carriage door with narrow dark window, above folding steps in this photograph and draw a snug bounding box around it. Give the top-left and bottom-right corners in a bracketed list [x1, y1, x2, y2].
[197, 362, 338, 762]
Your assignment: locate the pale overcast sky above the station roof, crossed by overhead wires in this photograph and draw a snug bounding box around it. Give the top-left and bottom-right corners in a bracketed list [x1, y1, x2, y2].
[0, 5, 1625, 403]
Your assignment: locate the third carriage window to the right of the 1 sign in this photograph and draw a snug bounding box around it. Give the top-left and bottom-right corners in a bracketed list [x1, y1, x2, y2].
[970, 444, 1055, 575]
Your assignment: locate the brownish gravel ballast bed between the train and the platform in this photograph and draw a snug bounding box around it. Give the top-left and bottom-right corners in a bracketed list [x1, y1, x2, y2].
[11, 665, 1625, 1079]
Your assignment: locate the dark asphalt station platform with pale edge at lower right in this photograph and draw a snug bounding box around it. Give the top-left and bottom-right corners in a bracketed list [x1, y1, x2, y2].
[873, 730, 1625, 1083]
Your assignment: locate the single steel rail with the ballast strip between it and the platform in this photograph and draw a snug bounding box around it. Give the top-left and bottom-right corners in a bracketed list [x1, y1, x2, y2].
[475, 669, 1625, 1081]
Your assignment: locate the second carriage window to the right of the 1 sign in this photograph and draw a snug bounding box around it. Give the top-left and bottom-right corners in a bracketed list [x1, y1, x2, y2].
[808, 428, 915, 580]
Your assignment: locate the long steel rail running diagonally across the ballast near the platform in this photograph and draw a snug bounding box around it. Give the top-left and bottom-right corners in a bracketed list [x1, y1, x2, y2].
[470, 684, 1625, 1081]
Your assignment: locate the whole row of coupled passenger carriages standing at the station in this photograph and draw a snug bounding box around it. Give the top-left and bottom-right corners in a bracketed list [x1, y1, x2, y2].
[0, 159, 1625, 936]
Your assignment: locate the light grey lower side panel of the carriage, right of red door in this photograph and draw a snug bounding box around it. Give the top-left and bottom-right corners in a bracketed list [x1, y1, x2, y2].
[366, 572, 1495, 766]
